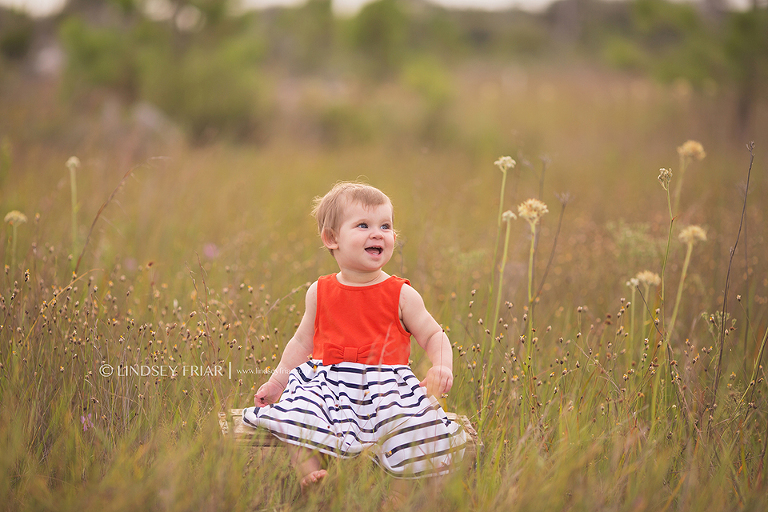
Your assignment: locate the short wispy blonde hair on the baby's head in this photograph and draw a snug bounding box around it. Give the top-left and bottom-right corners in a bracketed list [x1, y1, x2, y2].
[312, 181, 394, 254]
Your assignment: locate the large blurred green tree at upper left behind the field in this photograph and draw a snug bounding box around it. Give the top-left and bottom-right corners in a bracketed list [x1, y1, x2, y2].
[59, 0, 266, 142]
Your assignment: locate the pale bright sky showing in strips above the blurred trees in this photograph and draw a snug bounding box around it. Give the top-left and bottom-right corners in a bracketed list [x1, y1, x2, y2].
[0, 0, 752, 16]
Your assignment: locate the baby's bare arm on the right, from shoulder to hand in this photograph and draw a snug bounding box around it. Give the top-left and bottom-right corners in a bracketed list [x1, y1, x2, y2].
[400, 284, 453, 396]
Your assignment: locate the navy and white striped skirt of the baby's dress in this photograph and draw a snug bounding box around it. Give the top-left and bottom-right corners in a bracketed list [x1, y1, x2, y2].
[243, 361, 467, 478]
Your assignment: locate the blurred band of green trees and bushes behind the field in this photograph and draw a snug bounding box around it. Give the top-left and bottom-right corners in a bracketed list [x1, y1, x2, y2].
[0, 0, 768, 146]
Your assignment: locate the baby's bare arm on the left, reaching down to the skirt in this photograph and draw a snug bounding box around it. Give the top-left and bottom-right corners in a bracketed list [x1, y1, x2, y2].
[253, 282, 317, 407]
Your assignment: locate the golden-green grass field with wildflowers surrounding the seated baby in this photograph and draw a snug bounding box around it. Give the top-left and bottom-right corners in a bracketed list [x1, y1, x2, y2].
[0, 62, 768, 511]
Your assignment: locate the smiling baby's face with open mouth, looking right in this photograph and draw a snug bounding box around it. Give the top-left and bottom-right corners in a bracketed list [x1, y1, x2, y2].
[326, 202, 395, 272]
